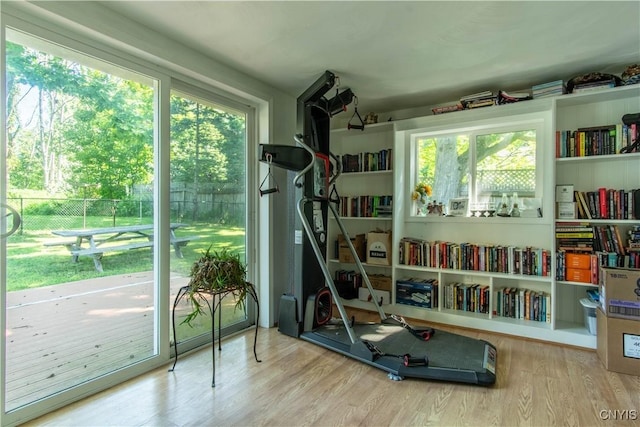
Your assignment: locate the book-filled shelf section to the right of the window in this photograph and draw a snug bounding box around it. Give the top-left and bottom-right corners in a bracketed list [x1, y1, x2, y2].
[554, 85, 640, 348]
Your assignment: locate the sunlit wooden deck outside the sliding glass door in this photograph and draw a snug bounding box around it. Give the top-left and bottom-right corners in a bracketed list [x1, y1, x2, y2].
[6, 272, 196, 410]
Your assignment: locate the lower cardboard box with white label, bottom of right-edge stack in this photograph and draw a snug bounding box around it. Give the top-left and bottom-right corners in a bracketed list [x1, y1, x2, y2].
[596, 308, 640, 375]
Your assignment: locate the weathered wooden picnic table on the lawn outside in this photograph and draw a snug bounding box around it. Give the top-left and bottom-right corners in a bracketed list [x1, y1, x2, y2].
[45, 223, 197, 272]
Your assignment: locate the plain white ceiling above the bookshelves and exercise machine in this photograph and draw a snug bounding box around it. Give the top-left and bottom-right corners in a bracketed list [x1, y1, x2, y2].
[101, 0, 640, 112]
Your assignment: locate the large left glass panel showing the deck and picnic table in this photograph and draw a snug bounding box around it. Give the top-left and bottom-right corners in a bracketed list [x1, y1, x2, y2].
[1, 30, 158, 411]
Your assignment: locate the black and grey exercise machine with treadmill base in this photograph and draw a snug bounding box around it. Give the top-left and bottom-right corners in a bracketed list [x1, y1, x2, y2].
[260, 71, 497, 385]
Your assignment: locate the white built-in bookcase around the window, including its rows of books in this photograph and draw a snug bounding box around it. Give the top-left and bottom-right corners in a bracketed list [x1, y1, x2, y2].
[329, 85, 640, 348]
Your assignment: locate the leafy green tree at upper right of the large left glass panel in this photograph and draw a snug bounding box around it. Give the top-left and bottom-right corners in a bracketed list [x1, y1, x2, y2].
[64, 75, 153, 199]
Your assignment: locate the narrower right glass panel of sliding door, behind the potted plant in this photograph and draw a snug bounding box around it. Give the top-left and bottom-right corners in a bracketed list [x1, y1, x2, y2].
[170, 89, 251, 351]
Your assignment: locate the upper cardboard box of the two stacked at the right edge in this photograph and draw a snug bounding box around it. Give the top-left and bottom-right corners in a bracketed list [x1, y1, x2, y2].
[600, 267, 640, 321]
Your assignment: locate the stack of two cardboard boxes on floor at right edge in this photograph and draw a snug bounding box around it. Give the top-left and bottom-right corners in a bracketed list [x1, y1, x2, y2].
[596, 268, 640, 375]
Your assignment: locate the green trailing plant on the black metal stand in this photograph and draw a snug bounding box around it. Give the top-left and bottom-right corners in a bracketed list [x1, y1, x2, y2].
[182, 246, 256, 324]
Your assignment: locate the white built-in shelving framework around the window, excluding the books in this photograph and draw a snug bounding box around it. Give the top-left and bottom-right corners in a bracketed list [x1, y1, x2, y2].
[328, 85, 640, 348]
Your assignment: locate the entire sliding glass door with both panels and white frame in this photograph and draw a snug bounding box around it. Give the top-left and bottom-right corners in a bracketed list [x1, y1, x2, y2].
[0, 15, 257, 423]
